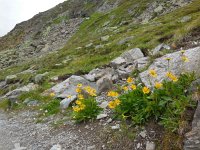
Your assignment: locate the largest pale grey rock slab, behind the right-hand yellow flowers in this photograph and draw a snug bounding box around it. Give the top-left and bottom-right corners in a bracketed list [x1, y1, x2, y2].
[139, 47, 200, 87]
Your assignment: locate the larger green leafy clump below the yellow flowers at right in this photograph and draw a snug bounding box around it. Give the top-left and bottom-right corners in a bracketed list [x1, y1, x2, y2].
[115, 74, 194, 131]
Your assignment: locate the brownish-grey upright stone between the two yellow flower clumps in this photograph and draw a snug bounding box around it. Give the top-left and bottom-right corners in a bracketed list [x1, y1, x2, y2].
[96, 75, 113, 94]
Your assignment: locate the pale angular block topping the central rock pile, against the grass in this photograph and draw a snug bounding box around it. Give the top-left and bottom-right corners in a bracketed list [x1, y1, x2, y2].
[121, 48, 144, 63]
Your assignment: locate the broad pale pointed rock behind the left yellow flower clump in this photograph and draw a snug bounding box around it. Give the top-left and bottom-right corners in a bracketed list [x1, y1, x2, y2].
[49, 75, 97, 98]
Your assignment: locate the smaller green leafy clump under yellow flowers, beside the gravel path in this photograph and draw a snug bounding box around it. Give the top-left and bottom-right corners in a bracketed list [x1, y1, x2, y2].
[72, 97, 102, 122]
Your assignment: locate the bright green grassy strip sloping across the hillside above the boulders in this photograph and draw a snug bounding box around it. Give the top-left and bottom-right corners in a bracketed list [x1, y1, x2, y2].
[0, 0, 200, 86]
